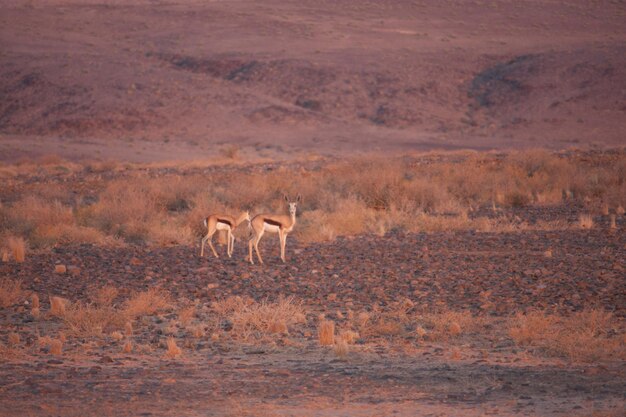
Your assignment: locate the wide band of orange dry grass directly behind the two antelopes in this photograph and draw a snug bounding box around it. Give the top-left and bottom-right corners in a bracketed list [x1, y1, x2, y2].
[0, 150, 626, 245]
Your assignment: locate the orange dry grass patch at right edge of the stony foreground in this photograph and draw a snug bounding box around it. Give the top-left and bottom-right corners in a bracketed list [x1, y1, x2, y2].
[509, 310, 626, 362]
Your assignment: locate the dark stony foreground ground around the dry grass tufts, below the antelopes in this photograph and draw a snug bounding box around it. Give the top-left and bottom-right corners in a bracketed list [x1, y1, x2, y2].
[0, 227, 626, 416]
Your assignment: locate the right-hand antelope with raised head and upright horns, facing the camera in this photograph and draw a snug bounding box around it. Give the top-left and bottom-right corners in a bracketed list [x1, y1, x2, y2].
[248, 195, 301, 264]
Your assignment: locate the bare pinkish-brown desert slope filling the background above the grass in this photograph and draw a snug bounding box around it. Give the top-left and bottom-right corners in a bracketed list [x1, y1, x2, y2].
[0, 1, 626, 159]
